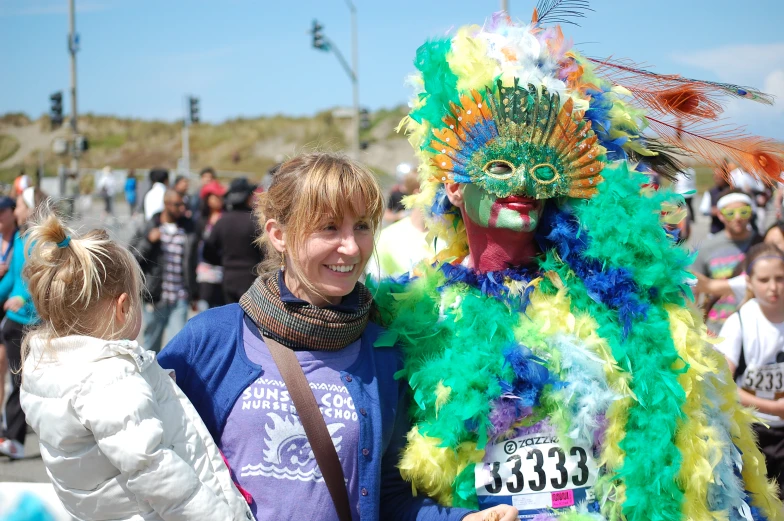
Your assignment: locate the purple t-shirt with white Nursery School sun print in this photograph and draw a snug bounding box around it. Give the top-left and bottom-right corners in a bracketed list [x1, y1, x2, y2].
[220, 323, 360, 521]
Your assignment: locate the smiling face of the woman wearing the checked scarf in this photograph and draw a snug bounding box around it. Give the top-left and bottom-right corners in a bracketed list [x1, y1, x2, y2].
[286, 207, 374, 306]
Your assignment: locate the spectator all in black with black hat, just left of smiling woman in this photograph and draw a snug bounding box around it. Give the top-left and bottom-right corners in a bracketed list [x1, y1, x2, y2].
[204, 177, 263, 304]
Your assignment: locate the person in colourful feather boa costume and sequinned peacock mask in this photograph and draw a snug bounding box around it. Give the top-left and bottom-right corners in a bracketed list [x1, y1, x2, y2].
[374, 5, 782, 521]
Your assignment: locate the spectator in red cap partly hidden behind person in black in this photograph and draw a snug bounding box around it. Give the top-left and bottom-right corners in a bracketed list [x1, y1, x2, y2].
[196, 181, 226, 310]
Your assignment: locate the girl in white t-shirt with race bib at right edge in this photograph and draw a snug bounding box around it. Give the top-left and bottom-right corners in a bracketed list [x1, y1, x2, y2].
[717, 243, 784, 497]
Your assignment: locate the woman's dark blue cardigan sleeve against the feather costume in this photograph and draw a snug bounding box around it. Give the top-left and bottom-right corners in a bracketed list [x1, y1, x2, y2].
[379, 372, 473, 521]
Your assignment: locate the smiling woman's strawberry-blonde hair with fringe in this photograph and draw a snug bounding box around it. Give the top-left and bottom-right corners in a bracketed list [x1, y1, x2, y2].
[256, 153, 384, 290]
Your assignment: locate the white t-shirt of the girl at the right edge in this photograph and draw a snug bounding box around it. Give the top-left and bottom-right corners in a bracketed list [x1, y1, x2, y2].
[716, 299, 784, 427]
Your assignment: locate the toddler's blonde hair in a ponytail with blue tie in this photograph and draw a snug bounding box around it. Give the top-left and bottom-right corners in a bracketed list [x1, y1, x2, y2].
[22, 205, 143, 341]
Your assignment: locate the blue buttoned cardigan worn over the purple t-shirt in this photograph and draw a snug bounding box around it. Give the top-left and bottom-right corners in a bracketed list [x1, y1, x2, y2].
[158, 304, 470, 521]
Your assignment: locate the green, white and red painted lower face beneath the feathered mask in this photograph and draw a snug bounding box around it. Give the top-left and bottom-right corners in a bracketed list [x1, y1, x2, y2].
[463, 184, 544, 232]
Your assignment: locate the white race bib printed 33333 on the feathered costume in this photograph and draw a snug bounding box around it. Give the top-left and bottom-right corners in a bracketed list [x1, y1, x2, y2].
[474, 434, 598, 519]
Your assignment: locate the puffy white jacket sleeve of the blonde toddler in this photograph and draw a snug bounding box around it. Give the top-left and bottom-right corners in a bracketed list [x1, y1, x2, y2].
[73, 370, 234, 521]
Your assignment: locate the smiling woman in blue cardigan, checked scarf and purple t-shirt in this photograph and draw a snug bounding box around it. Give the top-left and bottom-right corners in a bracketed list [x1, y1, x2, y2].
[160, 154, 517, 521]
